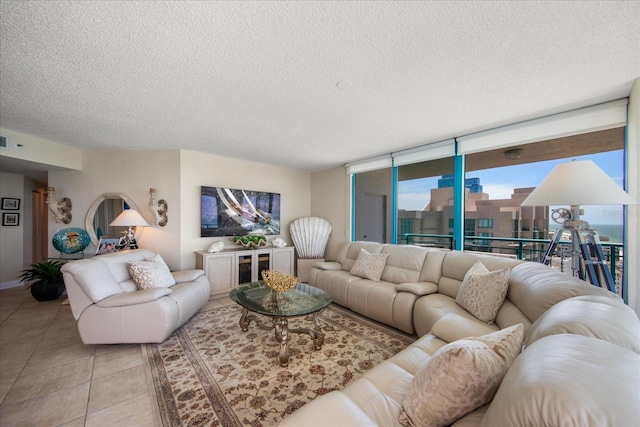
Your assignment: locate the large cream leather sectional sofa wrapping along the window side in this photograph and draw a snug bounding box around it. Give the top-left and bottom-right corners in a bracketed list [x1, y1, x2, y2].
[281, 242, 640, 427]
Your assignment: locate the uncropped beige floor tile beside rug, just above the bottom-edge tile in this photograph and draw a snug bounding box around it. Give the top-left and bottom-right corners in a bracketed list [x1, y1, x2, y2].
[88, 365, 148, 413]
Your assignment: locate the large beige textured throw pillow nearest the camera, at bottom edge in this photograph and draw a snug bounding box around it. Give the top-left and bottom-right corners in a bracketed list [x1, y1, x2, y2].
[400, 323, 524, 427]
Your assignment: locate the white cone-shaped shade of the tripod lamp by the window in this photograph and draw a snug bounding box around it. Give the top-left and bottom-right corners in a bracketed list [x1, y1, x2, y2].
[521, 160, 637, 206]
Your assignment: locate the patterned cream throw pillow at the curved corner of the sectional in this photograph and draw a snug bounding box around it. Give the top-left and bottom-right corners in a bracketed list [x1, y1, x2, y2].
[456, 261, 509, 324]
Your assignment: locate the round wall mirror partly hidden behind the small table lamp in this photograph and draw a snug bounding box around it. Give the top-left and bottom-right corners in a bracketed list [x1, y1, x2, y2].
[84, 193, 144, 246]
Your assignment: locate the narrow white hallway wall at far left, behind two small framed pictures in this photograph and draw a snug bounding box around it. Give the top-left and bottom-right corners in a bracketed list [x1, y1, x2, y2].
[0, 172, 25, 289]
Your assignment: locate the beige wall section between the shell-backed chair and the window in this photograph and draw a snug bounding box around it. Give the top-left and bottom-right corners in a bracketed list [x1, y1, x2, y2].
[311, 166, 351, 260]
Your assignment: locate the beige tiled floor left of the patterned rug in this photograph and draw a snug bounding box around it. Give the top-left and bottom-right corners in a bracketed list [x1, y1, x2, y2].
[0, 287, 230, 427]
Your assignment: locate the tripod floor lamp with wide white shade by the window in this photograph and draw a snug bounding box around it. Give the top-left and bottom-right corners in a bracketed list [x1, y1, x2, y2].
[521, 160, 637, 292]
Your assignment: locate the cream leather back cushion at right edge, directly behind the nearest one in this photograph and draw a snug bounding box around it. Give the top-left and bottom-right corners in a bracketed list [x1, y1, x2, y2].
[525, 295, 640, 353]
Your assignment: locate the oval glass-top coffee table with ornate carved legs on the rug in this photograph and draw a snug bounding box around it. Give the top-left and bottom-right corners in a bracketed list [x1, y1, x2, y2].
[229, 281, 331, 367]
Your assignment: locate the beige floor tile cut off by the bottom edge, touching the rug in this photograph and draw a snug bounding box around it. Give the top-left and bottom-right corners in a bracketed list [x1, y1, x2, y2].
[85, 393, 158, 427]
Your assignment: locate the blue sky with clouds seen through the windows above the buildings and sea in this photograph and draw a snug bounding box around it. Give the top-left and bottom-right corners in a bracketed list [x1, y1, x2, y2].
[398, 150, 624, 225]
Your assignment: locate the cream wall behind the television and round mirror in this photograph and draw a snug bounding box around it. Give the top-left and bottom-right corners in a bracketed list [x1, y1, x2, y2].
[49, 150, 310, 269]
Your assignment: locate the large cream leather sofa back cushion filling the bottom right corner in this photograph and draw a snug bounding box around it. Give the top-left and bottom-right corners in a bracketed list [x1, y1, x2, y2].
[482, 334, 640, 427]
